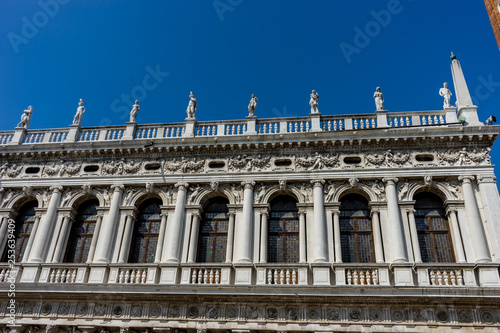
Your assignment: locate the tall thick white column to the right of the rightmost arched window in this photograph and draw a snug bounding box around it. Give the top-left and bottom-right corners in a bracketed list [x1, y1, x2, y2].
[458, 176, 491, 263]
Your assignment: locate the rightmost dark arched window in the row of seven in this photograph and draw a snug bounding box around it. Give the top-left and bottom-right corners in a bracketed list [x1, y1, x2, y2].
[415, 192, 455, 262]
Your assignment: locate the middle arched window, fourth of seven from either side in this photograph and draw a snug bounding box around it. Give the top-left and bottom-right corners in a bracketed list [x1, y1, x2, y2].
[197, 197, 229, 262]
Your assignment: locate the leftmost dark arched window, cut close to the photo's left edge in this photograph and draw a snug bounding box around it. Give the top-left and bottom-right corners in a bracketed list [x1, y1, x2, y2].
[2, 200, 38, 262]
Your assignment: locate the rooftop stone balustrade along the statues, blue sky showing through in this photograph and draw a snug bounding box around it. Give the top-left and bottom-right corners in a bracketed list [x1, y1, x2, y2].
[0, 110, 464, 145]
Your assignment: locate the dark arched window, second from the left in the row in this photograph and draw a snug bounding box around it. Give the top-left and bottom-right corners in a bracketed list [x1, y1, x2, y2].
[64, 199, 99, 263]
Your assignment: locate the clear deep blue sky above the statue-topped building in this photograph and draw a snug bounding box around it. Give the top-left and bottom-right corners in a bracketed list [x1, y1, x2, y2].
[0, 0, 500, 164]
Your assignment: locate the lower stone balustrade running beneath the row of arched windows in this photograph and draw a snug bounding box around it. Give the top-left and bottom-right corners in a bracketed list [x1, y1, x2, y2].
[0, 263, 500, 288]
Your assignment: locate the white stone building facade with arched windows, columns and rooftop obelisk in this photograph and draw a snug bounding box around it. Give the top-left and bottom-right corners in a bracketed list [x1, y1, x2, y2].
[0, 60, 500, 333]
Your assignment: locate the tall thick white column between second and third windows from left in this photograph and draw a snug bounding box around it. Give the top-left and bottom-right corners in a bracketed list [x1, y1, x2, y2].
[95, 185, 124, 264]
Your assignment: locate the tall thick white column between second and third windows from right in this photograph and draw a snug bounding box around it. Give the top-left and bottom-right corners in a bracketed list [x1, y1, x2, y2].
[311, 180, 328, 262]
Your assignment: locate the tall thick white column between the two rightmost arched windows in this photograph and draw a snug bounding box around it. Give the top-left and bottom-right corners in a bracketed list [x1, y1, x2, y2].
[382, 178, 408, 262]
